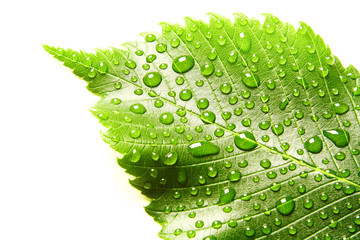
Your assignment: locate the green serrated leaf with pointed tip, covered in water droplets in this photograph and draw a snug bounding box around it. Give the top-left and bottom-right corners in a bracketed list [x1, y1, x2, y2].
[44, 14, 360, 240]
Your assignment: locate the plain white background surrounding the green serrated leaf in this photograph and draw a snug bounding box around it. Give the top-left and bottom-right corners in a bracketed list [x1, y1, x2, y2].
[0, 0, 360, 240]
